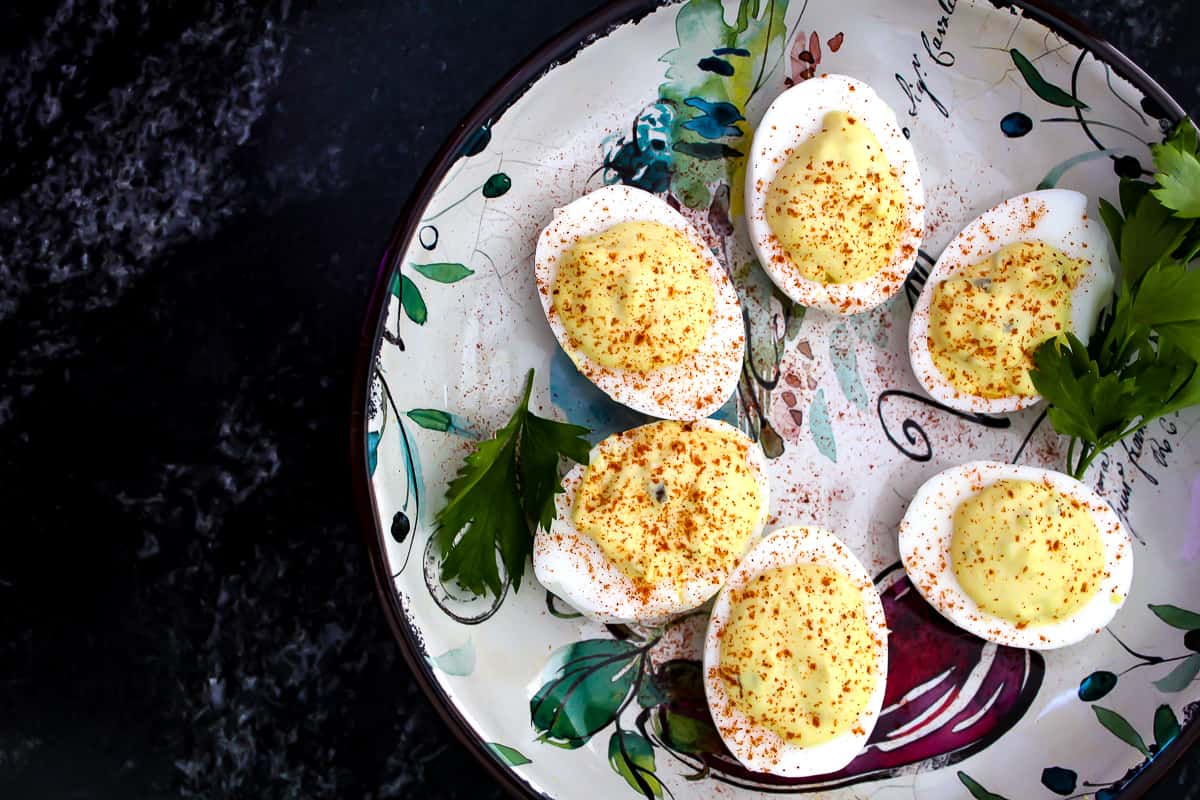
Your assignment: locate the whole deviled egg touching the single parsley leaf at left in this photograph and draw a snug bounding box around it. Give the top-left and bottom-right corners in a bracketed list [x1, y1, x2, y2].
[533, 420, 769, 624]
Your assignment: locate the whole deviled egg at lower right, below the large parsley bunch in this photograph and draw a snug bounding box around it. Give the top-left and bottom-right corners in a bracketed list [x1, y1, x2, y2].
[900, 461, 1133, 650]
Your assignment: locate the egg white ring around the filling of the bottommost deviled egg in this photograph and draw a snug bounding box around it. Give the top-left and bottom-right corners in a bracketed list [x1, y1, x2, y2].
[704, 525, 888, 777]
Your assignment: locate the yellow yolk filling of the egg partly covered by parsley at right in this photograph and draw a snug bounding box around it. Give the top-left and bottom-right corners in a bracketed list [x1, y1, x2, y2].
[928, 241, 1087, 398]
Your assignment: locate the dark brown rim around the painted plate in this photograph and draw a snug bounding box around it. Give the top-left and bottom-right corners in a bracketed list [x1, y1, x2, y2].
[349, 0, 1200, 800]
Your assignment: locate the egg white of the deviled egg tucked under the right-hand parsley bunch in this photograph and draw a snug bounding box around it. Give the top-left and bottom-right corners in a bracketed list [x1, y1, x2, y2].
[908, 188, 1112, 414]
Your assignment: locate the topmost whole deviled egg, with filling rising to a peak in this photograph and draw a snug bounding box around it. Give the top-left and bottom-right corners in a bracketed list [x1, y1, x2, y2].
[745, 74, 925, 314]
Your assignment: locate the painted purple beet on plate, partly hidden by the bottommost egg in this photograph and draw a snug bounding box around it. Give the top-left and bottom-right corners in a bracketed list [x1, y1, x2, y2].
[640, 564, 1045, 792]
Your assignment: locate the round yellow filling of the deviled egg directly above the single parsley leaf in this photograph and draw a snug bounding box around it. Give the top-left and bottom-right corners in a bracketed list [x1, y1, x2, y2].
[551, 222, 714, 373]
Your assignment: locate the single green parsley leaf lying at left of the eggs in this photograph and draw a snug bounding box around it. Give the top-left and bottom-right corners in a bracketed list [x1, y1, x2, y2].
[434, 369, 590, 596]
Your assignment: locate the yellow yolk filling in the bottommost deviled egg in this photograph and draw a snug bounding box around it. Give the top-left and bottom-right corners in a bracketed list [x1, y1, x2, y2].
[720, 564, 878, 746]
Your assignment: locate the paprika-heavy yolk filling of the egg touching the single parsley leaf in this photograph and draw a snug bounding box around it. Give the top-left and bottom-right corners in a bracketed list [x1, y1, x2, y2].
[572, 421, 762, 593]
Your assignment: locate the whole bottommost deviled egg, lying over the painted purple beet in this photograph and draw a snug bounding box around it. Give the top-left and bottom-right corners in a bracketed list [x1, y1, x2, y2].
[704, 527, 888, 777]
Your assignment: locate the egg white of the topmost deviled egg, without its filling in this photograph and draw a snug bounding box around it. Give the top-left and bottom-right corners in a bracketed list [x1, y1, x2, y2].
[745, 74, 925, 314]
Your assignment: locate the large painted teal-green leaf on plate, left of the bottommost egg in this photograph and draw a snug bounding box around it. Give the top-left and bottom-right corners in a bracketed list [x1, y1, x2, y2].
[529, 639, 641, 750]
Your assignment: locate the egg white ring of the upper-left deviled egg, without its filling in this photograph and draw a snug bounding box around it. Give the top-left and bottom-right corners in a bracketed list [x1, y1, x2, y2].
[534, 186, 745, 420]
